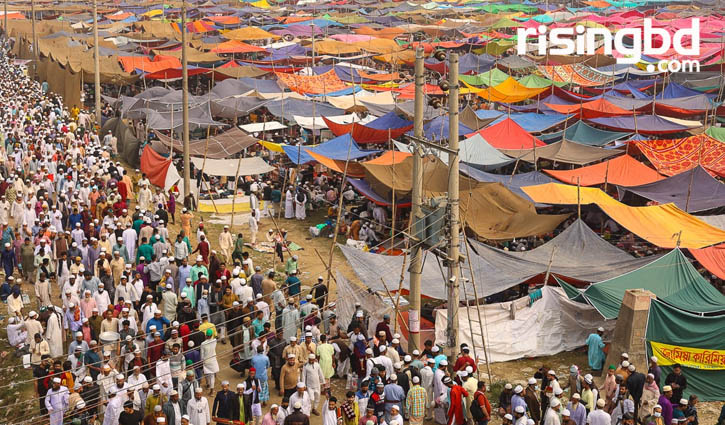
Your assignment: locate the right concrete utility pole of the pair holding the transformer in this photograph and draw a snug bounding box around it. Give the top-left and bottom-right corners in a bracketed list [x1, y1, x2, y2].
[447, 53, 461, 356]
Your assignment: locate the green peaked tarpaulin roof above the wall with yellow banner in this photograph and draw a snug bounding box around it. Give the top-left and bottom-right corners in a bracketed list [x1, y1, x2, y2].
[557, 249, 725, 319]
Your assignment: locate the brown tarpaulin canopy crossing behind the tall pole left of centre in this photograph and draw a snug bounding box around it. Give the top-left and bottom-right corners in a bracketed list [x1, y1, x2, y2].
[153, 127, 259, 159]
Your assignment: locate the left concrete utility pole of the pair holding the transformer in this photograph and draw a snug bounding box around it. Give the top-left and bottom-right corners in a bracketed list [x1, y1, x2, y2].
[408, 48, 425, 352]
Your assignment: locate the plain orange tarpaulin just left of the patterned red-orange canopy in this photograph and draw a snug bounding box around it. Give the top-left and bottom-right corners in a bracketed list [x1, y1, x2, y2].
[542, 155, 664, 186]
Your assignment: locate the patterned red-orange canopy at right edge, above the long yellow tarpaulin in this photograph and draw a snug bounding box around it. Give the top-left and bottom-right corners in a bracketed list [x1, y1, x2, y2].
[637, 134, 725, 176]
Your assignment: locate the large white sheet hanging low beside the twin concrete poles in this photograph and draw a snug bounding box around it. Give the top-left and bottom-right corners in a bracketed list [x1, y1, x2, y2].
[435, 286, 616, 363]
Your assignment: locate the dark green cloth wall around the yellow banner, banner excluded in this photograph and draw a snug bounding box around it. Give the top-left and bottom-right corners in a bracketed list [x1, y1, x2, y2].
[645, 300, 725, 401]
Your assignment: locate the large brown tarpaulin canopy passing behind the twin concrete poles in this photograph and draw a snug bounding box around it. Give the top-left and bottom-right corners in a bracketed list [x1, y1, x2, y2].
[363, 157, 568, 240]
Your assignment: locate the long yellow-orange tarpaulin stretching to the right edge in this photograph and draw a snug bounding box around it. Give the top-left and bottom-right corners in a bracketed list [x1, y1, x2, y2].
[521, 183, 725, 249]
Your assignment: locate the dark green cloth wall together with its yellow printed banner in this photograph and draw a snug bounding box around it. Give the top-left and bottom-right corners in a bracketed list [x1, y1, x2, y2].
[645, 300, 725, 401]
